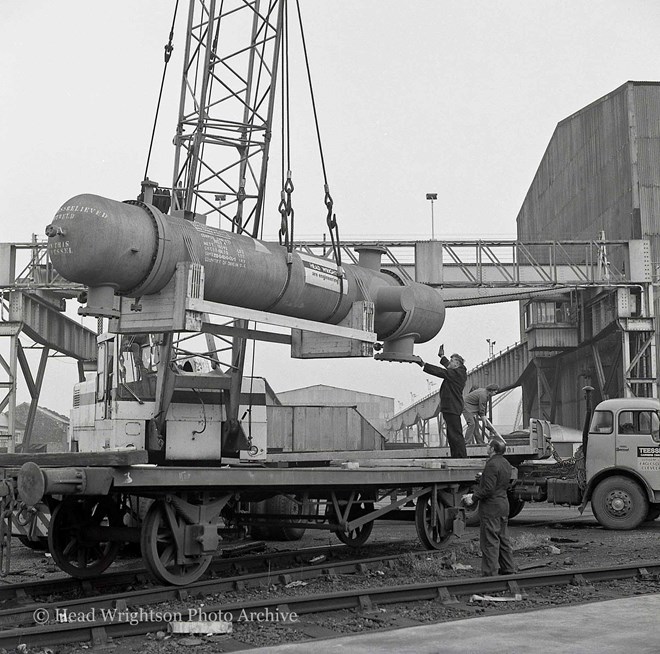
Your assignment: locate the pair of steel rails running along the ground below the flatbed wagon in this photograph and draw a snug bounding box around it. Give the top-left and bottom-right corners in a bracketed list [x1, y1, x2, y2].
[0, 556, 660, 649]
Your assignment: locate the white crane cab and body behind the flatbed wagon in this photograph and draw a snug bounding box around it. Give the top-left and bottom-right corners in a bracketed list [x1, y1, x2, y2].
[69, 334, 266, 463]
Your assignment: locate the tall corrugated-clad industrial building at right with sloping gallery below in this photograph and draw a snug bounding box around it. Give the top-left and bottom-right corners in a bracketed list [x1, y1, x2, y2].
[391, 81, 660, 434]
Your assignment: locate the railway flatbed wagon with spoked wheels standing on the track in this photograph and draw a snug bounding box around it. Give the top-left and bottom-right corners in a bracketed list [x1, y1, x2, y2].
[0, 451, 485, 585]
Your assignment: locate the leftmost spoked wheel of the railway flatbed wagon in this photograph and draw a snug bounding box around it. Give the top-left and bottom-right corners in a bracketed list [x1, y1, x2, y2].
[48, 497, 123, 579]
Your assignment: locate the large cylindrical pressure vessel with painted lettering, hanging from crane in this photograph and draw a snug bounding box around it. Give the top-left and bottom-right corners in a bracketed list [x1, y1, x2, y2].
[46, 194, 445, 343]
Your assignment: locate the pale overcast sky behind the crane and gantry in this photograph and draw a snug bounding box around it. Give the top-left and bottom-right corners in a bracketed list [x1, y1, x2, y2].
[0, 0, 660, 413]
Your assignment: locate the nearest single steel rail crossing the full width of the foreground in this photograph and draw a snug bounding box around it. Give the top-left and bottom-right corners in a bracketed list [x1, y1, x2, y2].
[0, 561, 660, 648]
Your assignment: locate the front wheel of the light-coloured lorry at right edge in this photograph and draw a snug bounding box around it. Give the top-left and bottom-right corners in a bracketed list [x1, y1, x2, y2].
[591, 476, 649, 529]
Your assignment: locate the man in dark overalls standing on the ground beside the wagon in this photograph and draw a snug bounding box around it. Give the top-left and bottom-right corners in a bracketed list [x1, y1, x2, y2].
[463, 439, 516, 577]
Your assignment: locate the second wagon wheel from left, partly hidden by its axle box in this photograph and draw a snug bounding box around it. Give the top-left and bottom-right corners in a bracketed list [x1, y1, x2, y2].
[140, 500, 212, 586]
